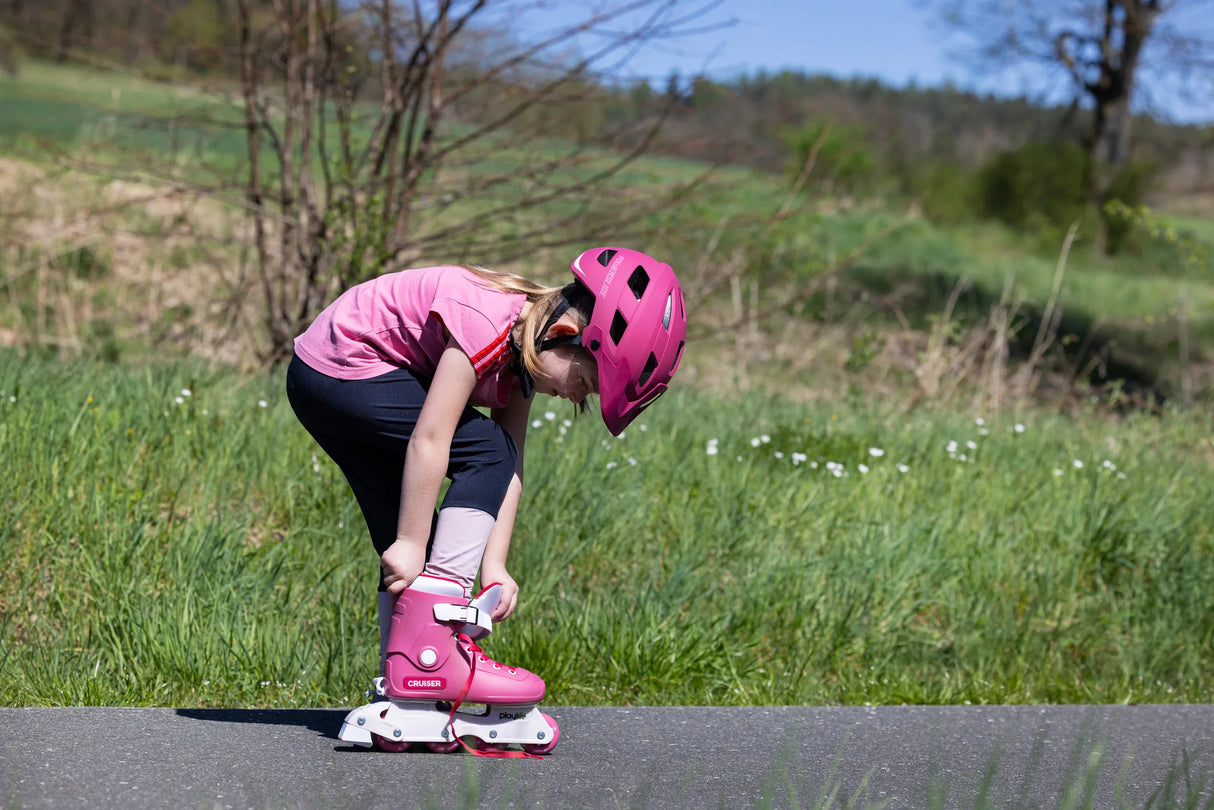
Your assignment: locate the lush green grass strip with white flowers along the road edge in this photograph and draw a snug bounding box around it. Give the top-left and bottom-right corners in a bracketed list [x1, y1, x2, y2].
[0, 355, 1214, 707]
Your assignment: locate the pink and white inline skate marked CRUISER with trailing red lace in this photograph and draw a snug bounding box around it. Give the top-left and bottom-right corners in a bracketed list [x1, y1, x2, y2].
[337, 574, 560, 755]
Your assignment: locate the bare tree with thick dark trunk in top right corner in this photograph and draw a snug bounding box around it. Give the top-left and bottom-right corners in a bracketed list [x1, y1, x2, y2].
[920, 0, 1214, 172]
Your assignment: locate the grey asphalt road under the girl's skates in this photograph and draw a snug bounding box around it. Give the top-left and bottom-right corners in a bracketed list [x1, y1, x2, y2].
[0, 706, 1214, 809]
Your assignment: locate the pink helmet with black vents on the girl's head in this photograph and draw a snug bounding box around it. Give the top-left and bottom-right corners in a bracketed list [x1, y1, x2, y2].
[571, 248, 687, 436]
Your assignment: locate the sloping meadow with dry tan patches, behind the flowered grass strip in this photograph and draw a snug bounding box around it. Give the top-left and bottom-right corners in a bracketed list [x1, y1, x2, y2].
[0, 62, 1214, 403]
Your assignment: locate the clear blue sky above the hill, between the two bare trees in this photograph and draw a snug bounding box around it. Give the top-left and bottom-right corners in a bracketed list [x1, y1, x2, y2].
[497, 0, 1214, 121]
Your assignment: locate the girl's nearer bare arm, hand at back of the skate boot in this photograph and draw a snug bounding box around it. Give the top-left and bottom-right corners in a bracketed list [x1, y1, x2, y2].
[381, 340, 476, 594]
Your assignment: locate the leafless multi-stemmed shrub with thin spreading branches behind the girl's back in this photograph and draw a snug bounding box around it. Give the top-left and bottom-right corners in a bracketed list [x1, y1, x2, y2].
[237, 0, 710, 359]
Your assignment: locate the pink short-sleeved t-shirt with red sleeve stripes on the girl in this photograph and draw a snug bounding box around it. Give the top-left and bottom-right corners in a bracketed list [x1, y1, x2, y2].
[295, 266, 527, 407]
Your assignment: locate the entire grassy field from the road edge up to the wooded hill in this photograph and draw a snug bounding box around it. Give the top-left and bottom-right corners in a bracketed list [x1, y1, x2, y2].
[0, 64, 1214, 707]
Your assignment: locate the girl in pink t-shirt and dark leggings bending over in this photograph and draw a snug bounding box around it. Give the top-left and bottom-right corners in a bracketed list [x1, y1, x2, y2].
[287, 248, 687, 752]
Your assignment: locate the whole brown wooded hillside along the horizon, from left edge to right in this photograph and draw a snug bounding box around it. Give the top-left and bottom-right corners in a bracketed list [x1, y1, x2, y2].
[0, 0, 1214, 194]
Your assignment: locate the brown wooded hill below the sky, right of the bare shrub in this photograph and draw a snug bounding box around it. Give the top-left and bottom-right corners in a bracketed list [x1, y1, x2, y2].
[570, 70, 1214, 193]
